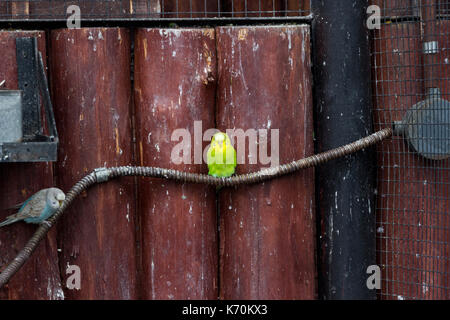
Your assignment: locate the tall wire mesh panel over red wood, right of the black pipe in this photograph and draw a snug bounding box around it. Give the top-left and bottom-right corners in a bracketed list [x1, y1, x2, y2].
[372, 0, 450, 300]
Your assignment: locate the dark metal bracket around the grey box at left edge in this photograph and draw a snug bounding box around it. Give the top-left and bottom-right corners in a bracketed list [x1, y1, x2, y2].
[0, 38, 58, 162]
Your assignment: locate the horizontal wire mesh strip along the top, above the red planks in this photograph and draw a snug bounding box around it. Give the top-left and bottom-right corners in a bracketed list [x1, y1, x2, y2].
[0, 0, 310, 21]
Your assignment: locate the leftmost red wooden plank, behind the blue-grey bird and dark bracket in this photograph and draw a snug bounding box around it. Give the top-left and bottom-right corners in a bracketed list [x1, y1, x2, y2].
[0, 31, 64, 299]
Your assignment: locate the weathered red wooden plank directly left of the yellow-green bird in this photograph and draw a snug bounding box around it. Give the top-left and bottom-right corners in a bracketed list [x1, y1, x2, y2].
[134, 29, 218, 299]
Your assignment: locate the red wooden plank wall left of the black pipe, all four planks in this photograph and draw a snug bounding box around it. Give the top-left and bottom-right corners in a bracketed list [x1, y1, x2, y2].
[0, 26, 317, 299]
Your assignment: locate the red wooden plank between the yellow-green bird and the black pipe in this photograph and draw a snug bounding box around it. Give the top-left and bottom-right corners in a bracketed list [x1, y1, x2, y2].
[216, 25, 316, 299]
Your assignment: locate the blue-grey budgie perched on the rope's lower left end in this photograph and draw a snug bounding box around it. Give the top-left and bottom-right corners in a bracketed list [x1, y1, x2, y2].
[0, 188, 66, 227]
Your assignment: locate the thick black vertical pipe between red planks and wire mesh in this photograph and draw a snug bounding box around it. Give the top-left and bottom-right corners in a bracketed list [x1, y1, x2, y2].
[312, 0, 376, 299]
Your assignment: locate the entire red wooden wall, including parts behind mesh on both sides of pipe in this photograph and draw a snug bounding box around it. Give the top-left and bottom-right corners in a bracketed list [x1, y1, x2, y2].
[0, 0, 450, 299]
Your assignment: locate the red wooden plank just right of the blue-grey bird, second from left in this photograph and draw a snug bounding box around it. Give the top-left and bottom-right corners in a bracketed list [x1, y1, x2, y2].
[50, 28, 137, 299]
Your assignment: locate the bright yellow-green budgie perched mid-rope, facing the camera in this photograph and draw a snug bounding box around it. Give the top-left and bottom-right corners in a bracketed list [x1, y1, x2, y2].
[207, 132, 237, 177]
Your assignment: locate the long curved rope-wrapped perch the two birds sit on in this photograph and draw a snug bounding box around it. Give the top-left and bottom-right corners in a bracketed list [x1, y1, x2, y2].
[0, 128, 392, 288]
